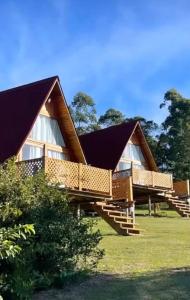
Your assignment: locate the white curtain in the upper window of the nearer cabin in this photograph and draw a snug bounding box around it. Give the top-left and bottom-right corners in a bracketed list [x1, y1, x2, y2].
[30, 115, 65, 146]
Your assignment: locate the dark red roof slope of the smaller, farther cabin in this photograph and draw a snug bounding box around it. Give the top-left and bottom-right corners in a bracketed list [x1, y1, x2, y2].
[79, 121, 138, 170]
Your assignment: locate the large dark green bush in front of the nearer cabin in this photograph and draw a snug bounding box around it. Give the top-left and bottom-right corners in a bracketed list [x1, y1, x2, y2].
[0, 161, 103, 300]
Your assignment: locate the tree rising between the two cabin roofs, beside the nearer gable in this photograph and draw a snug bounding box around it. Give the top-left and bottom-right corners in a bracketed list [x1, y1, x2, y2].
[69, 92, 99, 135]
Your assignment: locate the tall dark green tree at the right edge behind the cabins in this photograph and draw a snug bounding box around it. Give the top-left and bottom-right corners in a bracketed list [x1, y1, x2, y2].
[159, 89, 190, 179]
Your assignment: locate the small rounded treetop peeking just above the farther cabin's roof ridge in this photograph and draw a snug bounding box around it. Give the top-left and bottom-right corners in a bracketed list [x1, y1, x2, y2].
[98, 108, 125, 127]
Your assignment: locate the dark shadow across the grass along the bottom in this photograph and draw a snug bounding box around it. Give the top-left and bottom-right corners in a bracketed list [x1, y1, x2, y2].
[34, 268, 190, 300]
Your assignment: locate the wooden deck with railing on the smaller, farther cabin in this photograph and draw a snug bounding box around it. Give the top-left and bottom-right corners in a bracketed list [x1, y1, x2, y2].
[112, 168, 173, 201]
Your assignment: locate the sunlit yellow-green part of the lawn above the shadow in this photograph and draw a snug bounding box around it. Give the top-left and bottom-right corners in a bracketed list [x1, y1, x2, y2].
[97, 212, 190, 275]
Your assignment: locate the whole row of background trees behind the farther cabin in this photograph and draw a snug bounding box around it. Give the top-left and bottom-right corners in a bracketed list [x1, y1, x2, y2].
[71, 89, 190, 179]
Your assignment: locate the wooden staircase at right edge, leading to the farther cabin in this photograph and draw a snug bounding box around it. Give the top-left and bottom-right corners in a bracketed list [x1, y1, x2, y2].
[167, 196, 190, 218]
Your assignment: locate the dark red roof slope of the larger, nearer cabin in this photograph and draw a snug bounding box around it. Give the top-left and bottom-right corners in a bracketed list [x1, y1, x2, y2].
[0, 76, 59, 162]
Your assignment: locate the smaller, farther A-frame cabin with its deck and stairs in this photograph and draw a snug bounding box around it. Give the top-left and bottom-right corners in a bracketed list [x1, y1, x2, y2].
[80, 121, 190, 216]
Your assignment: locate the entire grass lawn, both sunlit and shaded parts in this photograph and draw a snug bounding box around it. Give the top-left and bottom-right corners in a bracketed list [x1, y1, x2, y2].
[35, 211, 190, 300]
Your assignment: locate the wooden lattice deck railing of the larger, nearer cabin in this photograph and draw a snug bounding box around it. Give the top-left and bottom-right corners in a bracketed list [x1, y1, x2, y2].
[18, 157, 112, 196]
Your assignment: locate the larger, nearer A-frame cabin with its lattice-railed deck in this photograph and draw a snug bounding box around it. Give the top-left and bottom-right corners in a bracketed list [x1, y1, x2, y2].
[0, 76, 112, 203]
